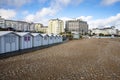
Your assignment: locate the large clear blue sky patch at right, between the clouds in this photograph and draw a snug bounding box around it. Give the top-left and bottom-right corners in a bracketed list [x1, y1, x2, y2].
[55, 0, 120, 19]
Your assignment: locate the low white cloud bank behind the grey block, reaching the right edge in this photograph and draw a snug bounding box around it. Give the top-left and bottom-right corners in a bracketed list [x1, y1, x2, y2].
[60, 13, 120, 29]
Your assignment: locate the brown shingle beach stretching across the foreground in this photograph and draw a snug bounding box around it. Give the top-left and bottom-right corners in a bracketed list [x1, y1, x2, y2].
[0, 39, 120, 80]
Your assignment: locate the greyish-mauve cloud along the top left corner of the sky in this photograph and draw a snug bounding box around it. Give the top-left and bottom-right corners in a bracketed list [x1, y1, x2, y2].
[0, 0, 31, 7]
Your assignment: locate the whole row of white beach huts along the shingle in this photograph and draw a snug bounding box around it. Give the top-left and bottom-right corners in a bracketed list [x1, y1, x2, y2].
[0, 31, 63, 54]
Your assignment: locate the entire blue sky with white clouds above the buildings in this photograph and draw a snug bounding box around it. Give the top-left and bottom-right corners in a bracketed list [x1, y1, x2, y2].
[0, 0, 120, 29]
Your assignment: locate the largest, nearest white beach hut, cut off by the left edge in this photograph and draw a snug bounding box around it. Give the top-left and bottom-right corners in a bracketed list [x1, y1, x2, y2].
[0, 31, 19, 54]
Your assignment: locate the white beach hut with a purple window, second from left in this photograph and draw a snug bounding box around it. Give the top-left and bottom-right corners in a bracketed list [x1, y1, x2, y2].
[15, 32, 33, 49]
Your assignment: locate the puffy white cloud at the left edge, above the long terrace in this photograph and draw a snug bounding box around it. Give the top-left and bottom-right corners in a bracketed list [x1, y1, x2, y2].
[0, 9, 16, 19]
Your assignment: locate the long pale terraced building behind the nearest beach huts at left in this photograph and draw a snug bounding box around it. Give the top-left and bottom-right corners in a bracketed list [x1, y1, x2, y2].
[0, 17, 35, 32]
